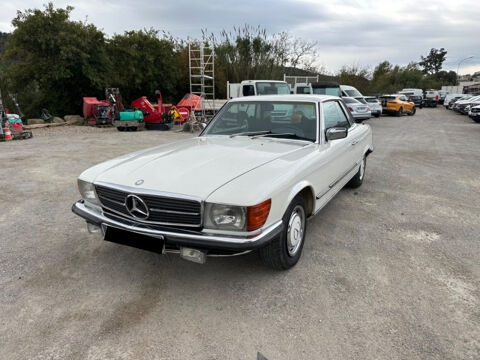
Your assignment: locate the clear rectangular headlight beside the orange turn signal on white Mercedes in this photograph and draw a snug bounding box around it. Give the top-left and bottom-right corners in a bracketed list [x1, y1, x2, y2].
[205, 203, 246, 231]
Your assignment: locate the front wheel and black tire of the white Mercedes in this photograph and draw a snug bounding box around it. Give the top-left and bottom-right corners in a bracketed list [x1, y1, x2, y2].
[259, 195, 307, 270]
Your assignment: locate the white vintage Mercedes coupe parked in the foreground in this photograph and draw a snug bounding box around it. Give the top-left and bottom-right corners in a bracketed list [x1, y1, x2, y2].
[72, 95, 373, 269]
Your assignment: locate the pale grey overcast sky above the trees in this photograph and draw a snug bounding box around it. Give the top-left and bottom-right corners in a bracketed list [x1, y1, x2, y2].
[0, 0, 480, 74]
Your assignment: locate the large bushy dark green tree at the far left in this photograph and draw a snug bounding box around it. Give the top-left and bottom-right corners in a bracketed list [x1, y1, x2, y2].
[4, 3, 109, 116]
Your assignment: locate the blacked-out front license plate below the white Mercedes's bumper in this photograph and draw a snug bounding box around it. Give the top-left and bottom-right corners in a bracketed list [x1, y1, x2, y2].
[104, 226, 165, 254]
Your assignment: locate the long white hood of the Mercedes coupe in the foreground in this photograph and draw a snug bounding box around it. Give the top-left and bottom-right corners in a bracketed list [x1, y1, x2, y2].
[88, 136, 309, 199]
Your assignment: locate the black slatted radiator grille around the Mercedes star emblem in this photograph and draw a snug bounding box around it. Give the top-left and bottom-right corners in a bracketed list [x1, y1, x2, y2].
[95, 185, 202, 227]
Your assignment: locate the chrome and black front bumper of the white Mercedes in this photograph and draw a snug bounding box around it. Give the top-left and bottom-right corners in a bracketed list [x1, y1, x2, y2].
[72, 200, 283, 252]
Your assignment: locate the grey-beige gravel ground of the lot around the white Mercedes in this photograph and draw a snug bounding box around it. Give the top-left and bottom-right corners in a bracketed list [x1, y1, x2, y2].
[0, 108, 480, 359]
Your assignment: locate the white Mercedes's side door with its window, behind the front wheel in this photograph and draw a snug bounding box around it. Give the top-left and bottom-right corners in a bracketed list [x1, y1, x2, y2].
[313, 99, 356, 210]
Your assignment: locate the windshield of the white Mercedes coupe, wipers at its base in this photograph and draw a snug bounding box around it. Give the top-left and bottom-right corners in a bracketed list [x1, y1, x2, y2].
[202, 101, 317, 141]
